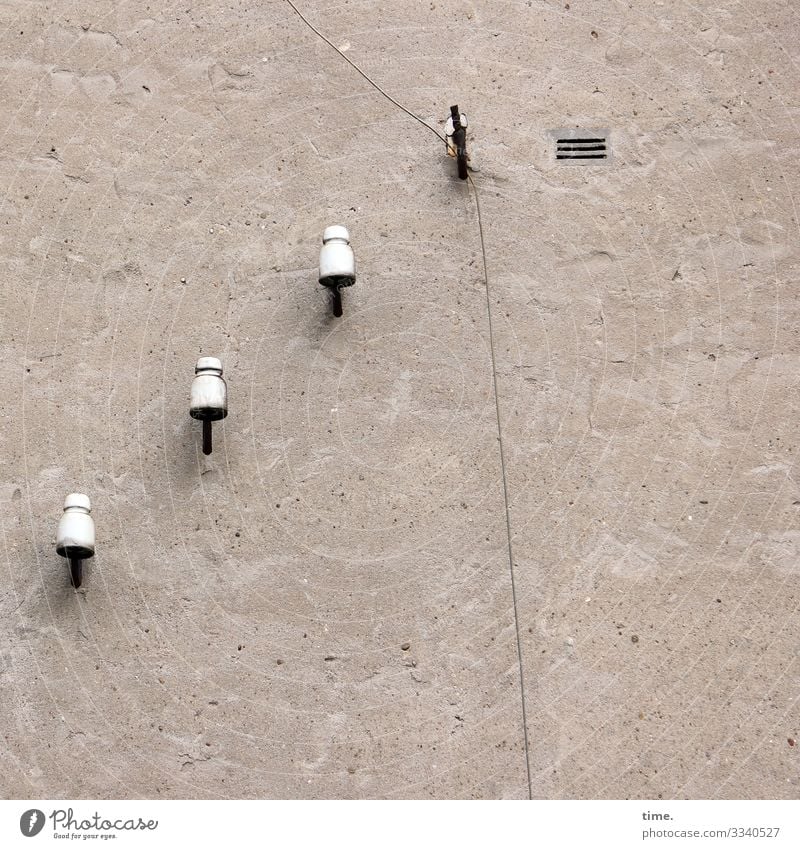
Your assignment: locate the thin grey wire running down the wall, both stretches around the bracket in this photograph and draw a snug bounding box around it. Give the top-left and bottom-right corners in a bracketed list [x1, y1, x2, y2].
[286, 0, 533, 799]
